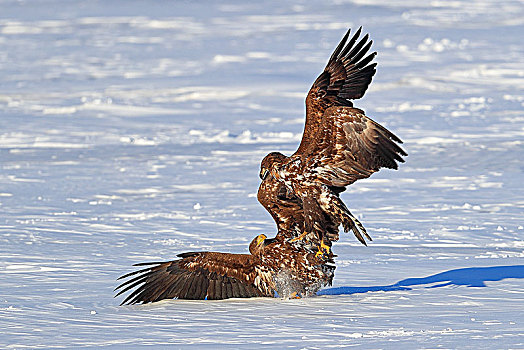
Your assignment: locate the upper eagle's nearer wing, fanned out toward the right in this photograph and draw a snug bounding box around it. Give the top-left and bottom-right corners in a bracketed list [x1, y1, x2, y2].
[310, 107, 407, 187]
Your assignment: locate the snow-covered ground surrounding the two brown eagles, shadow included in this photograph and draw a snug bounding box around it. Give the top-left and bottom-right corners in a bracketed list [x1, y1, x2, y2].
[0, 0, 524, 349]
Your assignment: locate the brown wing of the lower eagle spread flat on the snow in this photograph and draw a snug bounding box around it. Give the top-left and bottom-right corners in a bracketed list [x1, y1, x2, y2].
[115, 252, 273, 305]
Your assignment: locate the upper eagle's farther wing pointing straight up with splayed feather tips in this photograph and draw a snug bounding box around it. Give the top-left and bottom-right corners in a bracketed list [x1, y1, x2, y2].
[295, 27, 377, 154]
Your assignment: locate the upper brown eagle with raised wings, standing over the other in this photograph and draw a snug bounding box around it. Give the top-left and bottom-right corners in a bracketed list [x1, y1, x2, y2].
[258, 28, 407, 255]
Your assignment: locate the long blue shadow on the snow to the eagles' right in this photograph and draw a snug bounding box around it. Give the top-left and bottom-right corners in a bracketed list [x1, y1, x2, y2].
[317, 265, 524, 295]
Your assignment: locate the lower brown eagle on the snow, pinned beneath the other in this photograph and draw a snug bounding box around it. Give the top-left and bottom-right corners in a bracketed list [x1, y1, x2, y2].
[115, 235, 335, 305]
